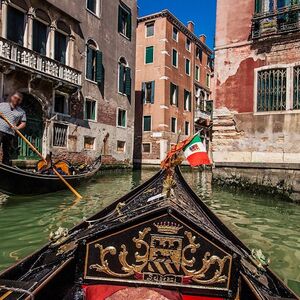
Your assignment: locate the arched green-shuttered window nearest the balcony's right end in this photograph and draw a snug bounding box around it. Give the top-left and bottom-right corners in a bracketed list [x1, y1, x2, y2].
[86, 40, 103, 83]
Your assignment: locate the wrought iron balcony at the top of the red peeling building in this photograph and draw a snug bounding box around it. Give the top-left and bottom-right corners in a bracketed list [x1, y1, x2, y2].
[252, 4, 300, 39]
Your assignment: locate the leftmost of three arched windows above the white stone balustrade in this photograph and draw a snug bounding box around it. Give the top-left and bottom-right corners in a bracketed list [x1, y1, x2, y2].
[6, 0, 28, 46]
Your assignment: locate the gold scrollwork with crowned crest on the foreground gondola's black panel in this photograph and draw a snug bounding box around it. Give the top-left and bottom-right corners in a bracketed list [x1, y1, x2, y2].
[89, 223, 231, 285]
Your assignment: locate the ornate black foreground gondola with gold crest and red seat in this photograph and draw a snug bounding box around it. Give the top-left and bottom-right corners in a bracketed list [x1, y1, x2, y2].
[0, 166, 298, 300]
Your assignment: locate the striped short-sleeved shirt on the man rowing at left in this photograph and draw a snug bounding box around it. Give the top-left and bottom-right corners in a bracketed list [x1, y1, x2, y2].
[0, 102, 26, 135]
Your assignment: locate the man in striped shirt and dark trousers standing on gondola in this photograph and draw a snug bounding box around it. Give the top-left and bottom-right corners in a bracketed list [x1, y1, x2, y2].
[0, 91, 26, 165]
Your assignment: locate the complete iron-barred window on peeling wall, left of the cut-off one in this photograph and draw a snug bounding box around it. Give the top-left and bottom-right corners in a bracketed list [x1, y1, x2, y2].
[257, 69, 287, 112]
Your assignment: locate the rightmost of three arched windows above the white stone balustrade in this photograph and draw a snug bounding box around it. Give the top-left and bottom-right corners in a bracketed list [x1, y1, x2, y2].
[54, 21, 71, 64]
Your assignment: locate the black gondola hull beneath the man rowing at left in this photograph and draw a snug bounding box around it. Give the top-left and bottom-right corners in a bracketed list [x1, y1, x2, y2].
[0, 158, 101, 195]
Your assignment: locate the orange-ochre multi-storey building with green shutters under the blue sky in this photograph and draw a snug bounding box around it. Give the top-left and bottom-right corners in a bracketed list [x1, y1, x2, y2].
[134, 10, 212, 164]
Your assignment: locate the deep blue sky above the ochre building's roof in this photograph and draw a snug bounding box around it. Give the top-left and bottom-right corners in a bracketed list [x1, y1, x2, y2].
[138, 0, 216, 48]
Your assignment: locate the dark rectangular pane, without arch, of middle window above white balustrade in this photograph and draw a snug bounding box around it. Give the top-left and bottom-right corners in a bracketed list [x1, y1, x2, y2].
[32, 20, 48, 55]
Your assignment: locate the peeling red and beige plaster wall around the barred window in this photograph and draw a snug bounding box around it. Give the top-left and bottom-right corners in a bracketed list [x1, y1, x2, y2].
[213, 0, 300, 163]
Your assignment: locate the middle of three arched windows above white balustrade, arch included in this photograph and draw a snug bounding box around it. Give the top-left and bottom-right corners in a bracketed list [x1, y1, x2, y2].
[32, 9, 51, 55]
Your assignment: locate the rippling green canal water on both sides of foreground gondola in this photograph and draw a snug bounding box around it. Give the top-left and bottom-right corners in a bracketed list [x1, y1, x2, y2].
[0, 169, 300, 295]
